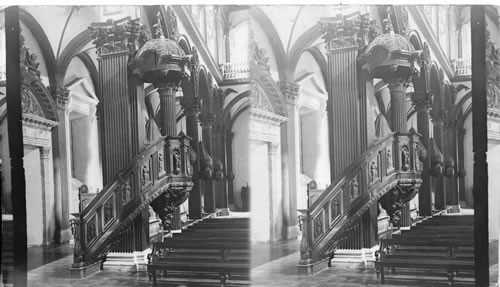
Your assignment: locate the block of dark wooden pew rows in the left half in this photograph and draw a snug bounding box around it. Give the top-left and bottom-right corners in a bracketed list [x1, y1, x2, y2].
[148, 217, 251, 286]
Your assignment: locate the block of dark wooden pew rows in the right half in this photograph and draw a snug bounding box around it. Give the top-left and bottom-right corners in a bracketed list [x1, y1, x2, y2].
[375, 215, 474, 286]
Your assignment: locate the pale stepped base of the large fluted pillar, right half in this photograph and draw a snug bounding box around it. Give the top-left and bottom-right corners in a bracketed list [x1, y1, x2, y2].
[332, 246, 379, 269]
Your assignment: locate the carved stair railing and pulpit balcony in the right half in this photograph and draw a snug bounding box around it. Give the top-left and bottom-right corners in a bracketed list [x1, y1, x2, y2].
[299, 132, 421, 265]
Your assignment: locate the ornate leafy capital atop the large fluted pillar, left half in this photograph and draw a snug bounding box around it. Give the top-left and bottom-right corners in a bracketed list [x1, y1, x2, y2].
[88, 17, 149, 56]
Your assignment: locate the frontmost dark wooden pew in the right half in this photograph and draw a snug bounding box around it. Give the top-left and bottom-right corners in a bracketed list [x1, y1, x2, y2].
[375, 237, 474, 286]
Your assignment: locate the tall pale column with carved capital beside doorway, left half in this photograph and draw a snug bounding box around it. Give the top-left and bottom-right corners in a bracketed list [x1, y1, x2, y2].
[52, 87, 72, 242]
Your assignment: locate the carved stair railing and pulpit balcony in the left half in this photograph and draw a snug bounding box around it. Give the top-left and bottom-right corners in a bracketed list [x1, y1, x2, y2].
[72, 135, 193, 267]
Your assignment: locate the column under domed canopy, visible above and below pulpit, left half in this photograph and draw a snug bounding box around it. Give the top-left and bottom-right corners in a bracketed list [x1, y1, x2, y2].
[155, 83, 182, 230]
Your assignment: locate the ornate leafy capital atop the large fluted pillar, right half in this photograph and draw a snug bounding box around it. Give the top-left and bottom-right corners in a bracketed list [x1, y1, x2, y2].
[318, 12, 377, 49]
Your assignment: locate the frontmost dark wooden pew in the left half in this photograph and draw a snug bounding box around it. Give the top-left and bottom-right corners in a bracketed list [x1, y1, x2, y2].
[148, 242, 250, 286]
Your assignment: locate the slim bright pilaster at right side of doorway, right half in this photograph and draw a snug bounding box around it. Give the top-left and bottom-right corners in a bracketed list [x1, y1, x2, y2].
[267, 142, 283, 242]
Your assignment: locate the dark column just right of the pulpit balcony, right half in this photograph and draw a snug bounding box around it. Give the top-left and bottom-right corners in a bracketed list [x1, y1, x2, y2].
[411, 92, 432, 216]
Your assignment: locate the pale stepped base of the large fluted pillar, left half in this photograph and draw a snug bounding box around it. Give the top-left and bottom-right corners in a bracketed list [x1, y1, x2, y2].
[103, 251, 151, 272]
